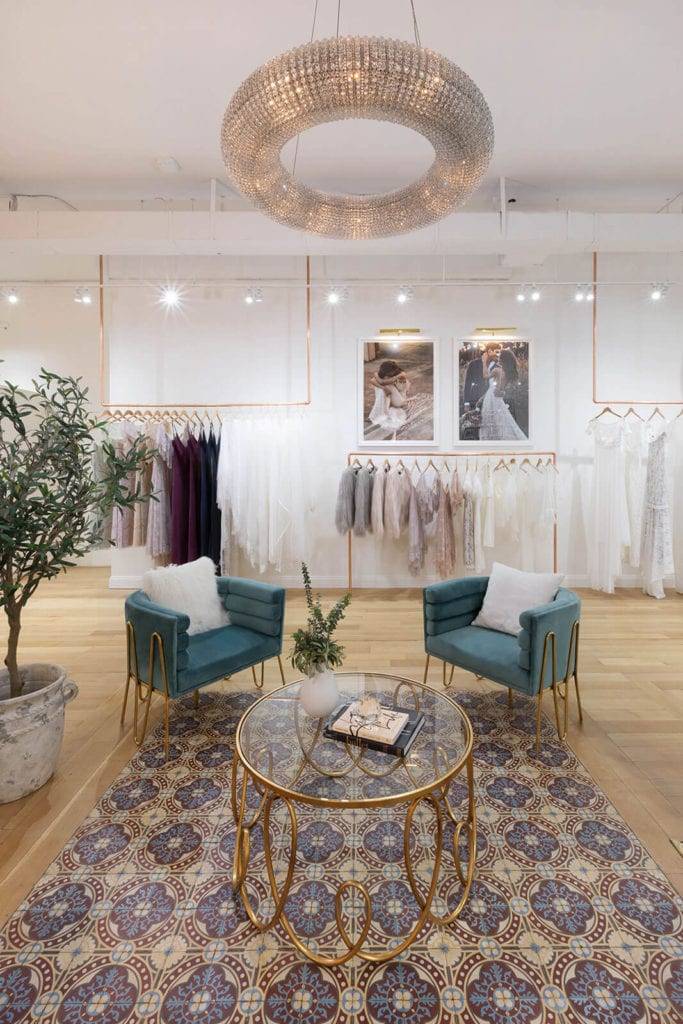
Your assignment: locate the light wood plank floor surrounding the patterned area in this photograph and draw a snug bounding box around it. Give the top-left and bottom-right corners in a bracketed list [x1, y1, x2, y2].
[0, 568, 683, 921]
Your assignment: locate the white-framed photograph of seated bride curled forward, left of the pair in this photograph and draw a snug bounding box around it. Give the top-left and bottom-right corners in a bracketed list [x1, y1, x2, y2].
[358, 335, 438, 447]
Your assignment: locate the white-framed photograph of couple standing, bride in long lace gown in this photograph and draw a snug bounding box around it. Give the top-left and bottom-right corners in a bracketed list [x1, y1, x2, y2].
[456, 336, 531, 449]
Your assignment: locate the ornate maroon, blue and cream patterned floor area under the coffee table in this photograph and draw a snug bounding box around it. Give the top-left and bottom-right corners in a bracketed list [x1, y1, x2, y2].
[0, 692, 683, 1024]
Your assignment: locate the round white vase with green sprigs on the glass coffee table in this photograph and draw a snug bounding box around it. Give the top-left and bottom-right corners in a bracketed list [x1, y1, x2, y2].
[291, 562, 351, 718]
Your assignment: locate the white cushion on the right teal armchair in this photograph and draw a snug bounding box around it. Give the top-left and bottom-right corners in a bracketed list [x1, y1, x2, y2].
[472, 562, 564, 636]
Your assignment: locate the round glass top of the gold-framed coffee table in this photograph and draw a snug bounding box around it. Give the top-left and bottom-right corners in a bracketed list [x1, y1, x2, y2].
[236, 672, 472, 807]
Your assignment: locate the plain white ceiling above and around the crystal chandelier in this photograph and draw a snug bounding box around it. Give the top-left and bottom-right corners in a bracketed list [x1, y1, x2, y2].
[0, 0, 683, 210]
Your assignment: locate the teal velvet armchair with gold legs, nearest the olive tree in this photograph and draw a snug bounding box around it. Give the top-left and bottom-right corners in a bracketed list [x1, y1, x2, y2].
[121, 577, 285, 755]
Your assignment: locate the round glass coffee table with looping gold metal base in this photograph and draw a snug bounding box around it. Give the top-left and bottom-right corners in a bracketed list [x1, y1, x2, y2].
[231, 672, 476, 967]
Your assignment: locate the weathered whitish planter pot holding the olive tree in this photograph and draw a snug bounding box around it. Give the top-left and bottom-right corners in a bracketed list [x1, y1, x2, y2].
[0, 663, 78, 804]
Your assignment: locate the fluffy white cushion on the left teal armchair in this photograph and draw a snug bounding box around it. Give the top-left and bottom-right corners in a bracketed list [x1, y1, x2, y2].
[142, 558, 228, 633]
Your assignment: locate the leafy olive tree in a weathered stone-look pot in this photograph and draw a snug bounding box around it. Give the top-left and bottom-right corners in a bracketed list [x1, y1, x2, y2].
[0, 370, 153, 803]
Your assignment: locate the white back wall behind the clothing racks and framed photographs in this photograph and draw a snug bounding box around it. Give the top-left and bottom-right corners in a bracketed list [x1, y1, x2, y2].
[0, 254, 683, 586]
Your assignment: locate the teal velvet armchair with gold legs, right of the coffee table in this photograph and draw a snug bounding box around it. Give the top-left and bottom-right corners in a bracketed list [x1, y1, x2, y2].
[423, 577, 584, 750]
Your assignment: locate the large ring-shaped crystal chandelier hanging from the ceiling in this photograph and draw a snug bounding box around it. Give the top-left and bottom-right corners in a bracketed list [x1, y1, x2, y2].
[221, 36, 494, 239]
